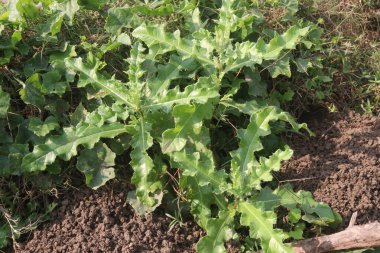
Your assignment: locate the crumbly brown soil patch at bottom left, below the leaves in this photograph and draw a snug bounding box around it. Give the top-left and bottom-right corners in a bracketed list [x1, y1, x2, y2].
[16, 186, 204, 253]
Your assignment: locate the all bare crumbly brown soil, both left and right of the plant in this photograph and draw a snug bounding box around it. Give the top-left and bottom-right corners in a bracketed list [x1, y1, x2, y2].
[16, 113, 380, 253]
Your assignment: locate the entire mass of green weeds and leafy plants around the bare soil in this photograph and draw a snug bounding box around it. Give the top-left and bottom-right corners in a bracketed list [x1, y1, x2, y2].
[0, 0, 378, 252]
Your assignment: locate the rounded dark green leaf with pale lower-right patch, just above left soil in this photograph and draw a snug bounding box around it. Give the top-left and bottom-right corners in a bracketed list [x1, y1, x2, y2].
[77, 142, 116, 190]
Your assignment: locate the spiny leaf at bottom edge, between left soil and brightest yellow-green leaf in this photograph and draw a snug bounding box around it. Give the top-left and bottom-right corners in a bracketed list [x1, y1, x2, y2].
[197, 210, 235, 253]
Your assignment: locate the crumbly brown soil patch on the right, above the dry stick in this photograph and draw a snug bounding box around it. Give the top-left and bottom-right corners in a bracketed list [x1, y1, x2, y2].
[280, 112, 380, 225]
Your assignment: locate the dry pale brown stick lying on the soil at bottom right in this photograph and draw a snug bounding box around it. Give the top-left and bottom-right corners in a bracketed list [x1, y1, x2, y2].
[291, 222, 380, 253]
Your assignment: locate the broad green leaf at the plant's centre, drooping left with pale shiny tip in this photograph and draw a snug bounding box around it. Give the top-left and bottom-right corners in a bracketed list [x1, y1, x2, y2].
[161, 103, 212, 154]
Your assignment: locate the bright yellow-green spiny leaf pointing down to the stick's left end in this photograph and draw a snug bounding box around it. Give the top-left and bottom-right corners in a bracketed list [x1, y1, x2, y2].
[238, 201, 293, 253]
